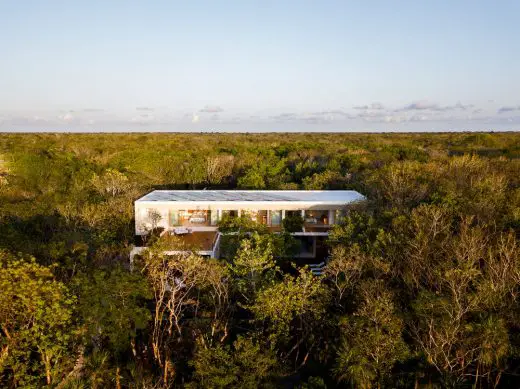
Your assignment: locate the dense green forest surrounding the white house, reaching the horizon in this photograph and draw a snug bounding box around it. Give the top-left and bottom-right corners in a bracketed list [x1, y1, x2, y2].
[0, 133, 520, 389]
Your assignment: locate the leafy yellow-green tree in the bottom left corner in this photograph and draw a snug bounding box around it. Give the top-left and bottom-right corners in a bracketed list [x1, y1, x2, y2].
[0, 251, 75, 386]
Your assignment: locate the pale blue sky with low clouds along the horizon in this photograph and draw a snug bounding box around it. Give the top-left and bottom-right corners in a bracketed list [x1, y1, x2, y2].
[0, 0, 520, 132]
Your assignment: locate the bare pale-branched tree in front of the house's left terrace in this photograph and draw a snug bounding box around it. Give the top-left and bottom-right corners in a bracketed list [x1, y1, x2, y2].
[144, 251, 229, 386]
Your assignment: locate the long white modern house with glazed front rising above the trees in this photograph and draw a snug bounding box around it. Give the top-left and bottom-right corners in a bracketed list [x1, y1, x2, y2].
[135, 190, 365, 258]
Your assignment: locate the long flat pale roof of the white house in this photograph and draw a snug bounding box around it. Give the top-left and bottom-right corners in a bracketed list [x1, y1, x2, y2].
[136, 190, 365, 204]
